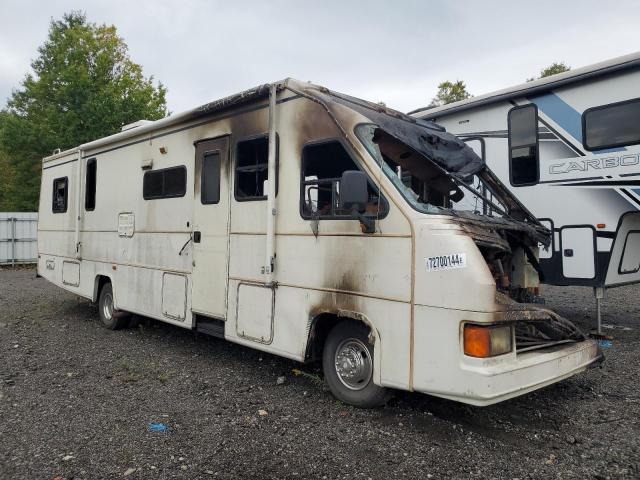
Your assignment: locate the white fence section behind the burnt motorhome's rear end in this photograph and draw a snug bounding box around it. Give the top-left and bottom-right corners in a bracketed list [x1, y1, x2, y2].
[0, 212, 38, 265]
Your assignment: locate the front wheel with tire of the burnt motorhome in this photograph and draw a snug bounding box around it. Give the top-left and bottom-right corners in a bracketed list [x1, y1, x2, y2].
[322, 321, 391, 408]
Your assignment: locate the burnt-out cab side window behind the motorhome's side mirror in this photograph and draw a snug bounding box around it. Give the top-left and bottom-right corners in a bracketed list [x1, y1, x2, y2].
[300, 140, 387, 219]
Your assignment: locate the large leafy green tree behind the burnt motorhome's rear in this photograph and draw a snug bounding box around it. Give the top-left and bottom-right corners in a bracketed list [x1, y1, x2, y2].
[0, 12, 168, 210]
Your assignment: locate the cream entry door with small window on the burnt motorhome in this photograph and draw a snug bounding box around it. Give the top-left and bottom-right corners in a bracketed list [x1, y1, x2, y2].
[191, 137, 230, 319]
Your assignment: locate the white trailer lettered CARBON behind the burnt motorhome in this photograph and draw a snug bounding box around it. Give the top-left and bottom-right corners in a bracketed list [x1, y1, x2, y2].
[410, 53, 640, 288]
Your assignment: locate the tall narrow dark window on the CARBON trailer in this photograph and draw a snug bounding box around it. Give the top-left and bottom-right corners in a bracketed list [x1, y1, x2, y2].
[507, 105, 540, 187]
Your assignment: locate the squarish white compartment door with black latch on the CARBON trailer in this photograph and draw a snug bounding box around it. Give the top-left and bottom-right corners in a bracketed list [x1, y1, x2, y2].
[560, 227, 596, 279]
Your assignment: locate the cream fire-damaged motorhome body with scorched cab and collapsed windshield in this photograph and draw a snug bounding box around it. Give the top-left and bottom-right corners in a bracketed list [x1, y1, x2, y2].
[38, 79, 600, 405]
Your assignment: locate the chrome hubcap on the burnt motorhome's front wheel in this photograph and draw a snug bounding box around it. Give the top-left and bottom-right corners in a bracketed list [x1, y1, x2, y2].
[335, 338, 373, 390]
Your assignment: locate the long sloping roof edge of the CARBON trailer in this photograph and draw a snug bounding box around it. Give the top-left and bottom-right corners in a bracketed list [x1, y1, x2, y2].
[409, 52, 640, 119]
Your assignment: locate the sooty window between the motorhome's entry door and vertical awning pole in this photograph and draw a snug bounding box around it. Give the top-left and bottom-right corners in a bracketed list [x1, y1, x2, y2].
[234, 136, 278, 201]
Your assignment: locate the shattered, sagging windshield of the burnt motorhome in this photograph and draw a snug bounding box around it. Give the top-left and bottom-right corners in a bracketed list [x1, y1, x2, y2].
[355, 124, 506, 216]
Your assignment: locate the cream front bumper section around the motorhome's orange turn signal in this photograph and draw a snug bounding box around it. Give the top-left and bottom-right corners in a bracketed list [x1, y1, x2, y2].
[414, 307, 603, 406]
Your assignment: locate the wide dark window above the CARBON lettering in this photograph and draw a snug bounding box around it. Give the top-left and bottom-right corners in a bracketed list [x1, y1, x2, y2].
[582, 98, 640, 150]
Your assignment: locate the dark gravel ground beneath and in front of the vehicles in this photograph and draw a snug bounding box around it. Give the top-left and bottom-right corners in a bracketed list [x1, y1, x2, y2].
[0, 269, 640, 480]
